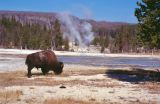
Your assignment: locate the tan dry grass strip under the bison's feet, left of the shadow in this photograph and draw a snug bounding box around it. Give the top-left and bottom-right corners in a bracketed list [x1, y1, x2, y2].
[0, 70, 105, 87]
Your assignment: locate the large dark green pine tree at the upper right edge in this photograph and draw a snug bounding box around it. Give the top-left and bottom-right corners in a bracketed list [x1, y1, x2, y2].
[135, 0, 160, 49]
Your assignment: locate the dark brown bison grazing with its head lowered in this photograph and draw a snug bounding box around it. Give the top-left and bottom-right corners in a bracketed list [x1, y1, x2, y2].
[25, 50, 64, 77]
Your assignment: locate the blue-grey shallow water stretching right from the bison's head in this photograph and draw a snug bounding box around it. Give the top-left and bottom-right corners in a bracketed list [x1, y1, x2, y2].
[58, 56, 160, 68]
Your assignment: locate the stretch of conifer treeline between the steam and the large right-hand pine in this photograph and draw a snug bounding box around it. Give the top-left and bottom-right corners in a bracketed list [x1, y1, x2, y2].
[93, 25, 139, 53]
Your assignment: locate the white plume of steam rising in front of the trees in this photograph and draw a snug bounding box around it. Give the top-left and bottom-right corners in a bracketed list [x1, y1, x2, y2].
[57, 13, 94, 47]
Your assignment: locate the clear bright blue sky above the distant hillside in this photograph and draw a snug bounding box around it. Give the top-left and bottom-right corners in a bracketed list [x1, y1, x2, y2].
[0, 0, 140, 23]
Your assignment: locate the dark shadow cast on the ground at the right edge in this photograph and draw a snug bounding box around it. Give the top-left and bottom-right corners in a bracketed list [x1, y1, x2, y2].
[105, 68, 160, 83]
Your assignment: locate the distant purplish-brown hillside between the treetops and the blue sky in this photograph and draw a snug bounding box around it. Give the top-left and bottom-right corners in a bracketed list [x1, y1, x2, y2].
[0, 11, 128, 29]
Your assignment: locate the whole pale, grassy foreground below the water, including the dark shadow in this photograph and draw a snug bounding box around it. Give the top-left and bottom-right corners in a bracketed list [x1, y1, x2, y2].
[0, 65, 160, 104]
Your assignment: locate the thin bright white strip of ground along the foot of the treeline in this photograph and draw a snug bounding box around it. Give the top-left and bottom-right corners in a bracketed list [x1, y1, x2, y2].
[0, 49, 160, 58]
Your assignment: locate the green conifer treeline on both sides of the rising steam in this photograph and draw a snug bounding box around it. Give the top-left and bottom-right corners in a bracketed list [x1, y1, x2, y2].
[0, 17, 138, 53]
